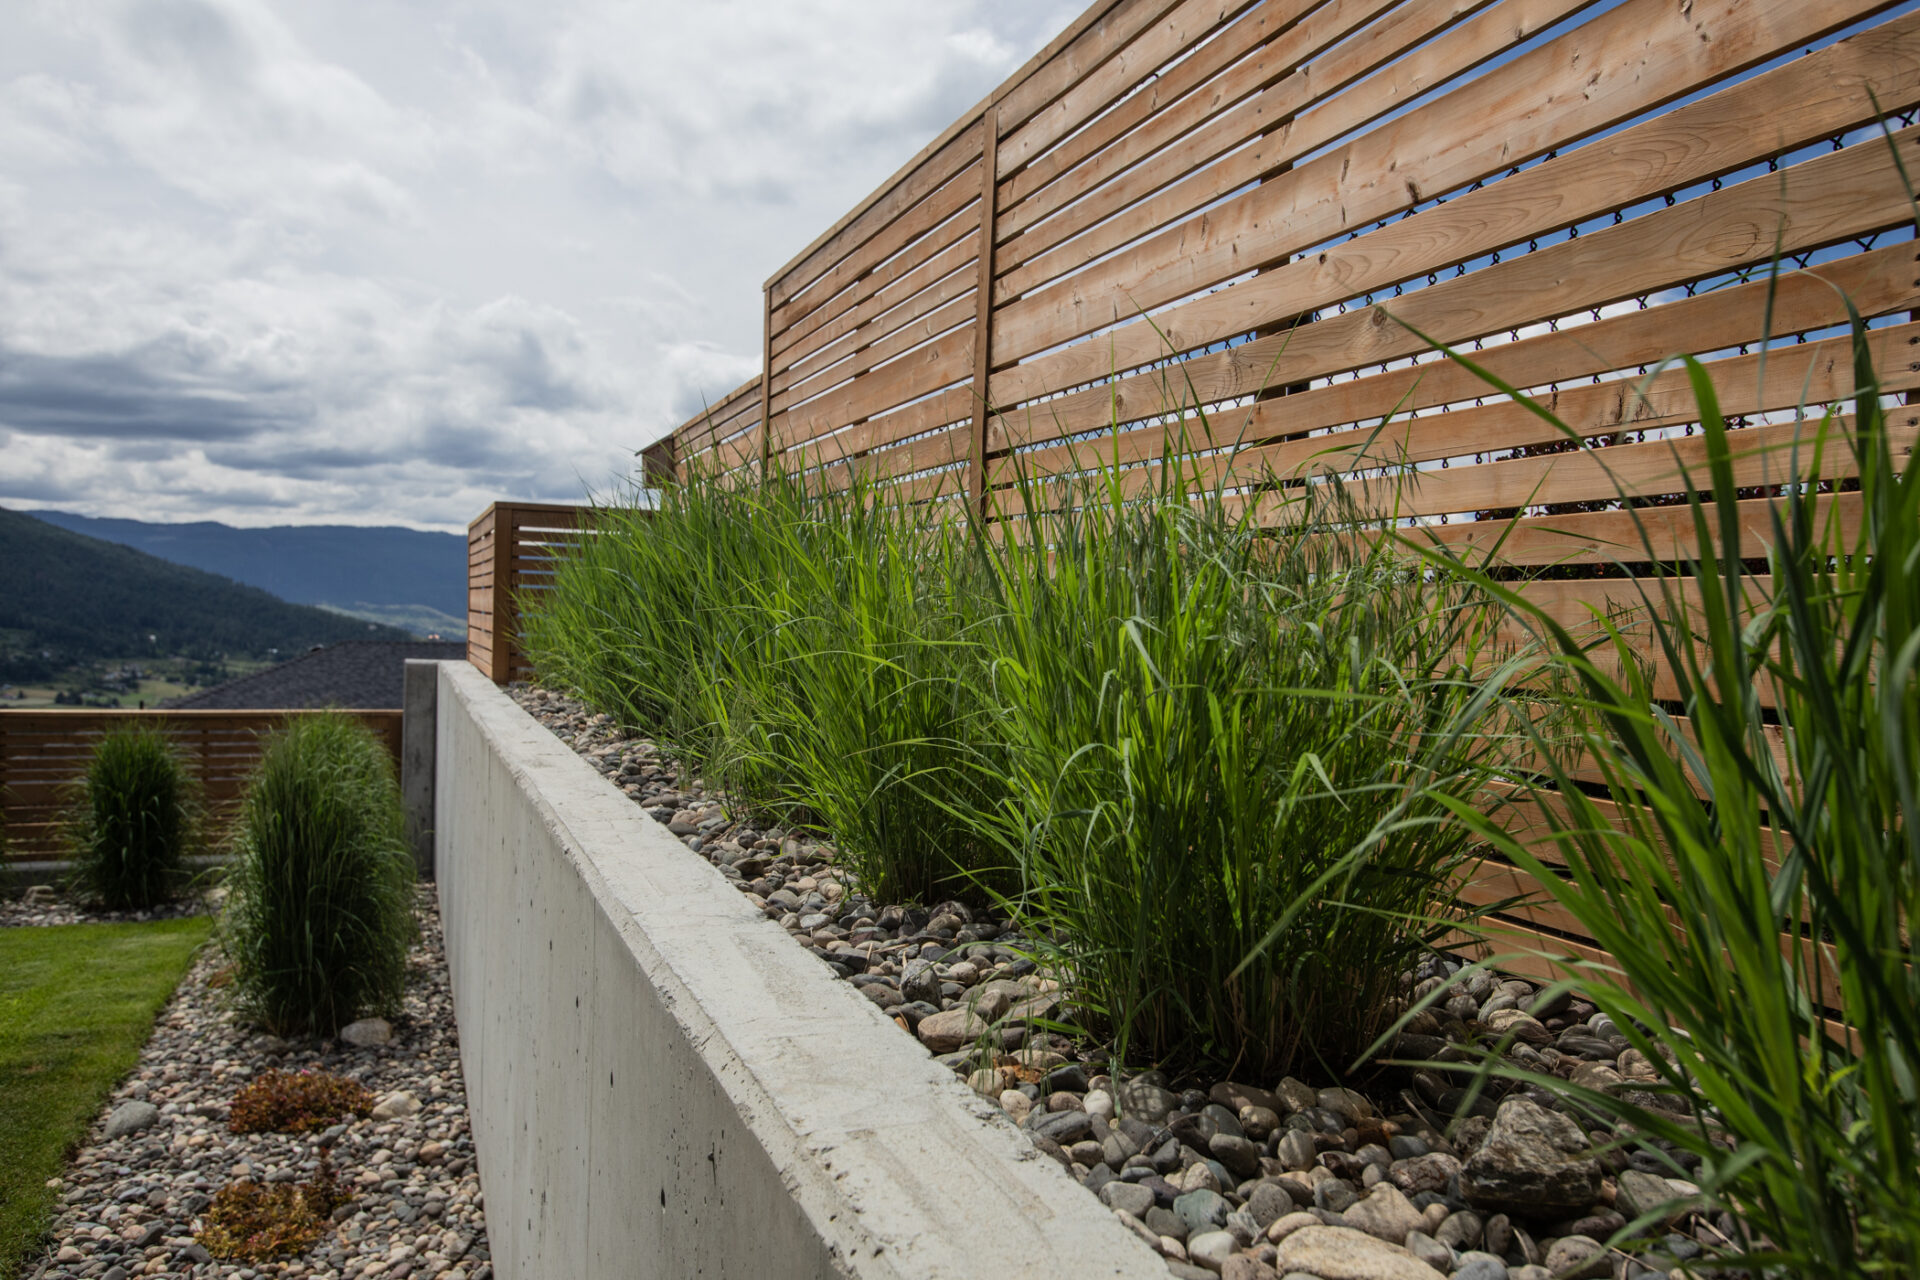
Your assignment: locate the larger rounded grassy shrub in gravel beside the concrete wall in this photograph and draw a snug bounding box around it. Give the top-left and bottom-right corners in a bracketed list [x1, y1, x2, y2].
[223, 716, 413, 1034]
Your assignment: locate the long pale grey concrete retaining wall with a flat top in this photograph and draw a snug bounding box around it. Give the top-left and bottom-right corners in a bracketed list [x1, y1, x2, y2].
[434, 662, 1167, 1280]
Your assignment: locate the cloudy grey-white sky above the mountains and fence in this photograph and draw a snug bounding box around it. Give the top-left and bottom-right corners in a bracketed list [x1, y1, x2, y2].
[0, 0, 1083, 528]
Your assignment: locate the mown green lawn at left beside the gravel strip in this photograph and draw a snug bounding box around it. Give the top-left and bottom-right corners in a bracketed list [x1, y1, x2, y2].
[0, 917, 211, 1280]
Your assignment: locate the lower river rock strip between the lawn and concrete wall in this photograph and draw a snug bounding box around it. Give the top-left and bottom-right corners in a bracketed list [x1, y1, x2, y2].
[25, 887, 493, 1280]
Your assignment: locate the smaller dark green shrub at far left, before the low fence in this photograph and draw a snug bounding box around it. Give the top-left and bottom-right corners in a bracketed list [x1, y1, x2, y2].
[71, 723, 200, 912]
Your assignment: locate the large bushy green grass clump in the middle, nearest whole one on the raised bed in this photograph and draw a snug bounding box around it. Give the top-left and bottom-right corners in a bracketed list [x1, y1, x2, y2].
[981, 459, 1492, 1079]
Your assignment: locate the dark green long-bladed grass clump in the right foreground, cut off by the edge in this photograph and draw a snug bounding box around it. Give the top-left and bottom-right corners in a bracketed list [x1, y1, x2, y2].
[1428, 297, 1920, 1278]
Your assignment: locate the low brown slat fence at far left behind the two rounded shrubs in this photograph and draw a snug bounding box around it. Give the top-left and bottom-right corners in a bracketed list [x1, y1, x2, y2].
[0, 708, 399, 862]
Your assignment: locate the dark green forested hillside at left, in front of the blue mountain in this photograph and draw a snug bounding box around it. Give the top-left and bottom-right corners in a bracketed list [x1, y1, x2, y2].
[0, 509, 409, 681]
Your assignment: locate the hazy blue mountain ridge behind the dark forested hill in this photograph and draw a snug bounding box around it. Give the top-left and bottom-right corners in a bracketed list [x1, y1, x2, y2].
[25, 510, 467, 639]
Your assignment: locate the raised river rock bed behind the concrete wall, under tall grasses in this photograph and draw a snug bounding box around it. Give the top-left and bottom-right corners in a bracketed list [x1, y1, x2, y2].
[511, 685, 1732, 1280]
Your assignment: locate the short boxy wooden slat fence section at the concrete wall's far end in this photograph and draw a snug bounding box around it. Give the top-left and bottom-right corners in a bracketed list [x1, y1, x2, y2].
[467, 498, 599, 685]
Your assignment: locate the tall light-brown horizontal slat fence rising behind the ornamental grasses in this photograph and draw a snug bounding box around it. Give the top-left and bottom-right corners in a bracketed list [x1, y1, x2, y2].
[649, 0, 1920, 982]
